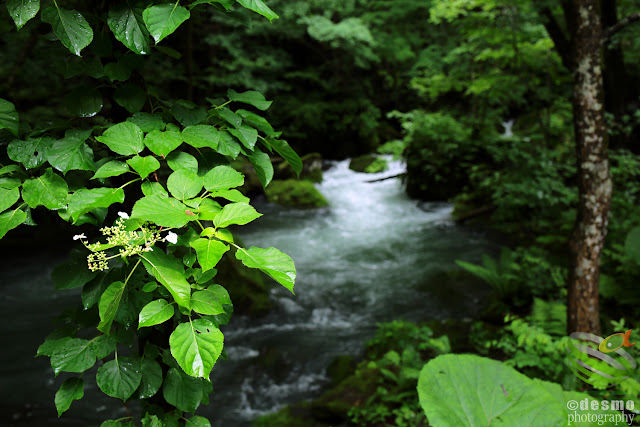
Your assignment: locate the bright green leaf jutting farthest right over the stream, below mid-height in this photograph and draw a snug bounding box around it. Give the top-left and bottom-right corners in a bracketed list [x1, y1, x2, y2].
[236, 247, 296, 293]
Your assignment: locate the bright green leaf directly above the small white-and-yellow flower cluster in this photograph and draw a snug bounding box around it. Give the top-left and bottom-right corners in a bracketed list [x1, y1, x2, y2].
[131, 196, 196, 228]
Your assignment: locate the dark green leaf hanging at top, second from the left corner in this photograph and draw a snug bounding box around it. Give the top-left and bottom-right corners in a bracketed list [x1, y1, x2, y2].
[42, 3, 93, 56]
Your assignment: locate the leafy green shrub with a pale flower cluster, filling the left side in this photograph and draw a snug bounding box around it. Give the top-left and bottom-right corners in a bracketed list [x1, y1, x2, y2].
[0, 0, 302, 426]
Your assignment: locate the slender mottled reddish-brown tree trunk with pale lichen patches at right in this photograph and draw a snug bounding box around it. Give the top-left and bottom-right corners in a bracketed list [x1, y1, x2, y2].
[567, 0, 612, 335]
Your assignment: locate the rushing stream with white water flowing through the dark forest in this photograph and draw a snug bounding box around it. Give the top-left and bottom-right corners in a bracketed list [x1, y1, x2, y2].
[0, 160, 495, 427]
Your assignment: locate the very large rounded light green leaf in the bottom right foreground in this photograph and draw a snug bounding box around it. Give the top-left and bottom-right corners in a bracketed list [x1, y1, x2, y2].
[418, 354, 616, 427]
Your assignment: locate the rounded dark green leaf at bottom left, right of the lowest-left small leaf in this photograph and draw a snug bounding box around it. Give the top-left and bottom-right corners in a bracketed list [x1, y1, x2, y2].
[96, 357, 142, 401]
